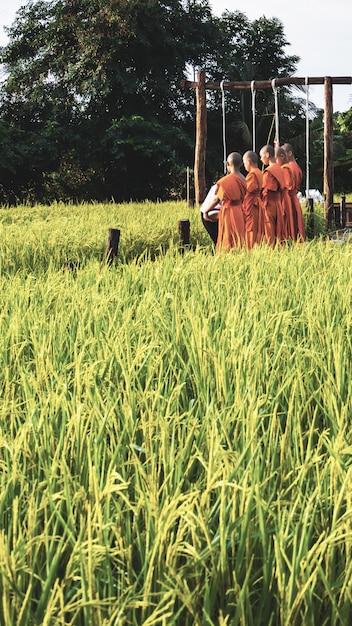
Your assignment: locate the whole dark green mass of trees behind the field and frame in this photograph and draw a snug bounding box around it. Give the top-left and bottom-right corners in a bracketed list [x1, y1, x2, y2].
[0, 0, 346, 202]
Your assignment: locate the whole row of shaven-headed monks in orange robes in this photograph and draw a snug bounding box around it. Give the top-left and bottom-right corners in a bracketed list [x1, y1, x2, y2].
[201, 143, 305, 252]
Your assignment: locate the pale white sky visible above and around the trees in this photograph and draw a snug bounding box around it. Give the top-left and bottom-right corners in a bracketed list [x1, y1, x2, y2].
[0, 0, 352, 111]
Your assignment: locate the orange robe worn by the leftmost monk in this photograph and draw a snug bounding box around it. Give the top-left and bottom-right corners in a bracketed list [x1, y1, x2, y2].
[216, 174, 246, 252]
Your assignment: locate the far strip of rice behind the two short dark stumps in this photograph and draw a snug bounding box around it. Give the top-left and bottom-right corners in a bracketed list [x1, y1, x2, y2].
[0, 201, 210, 274]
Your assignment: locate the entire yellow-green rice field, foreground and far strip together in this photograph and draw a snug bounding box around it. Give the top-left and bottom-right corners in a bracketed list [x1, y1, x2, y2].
[0, 203, 352, 626]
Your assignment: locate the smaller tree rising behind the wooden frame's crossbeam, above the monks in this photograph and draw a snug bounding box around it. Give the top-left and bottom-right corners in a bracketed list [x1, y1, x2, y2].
[207, 11, 304, 178]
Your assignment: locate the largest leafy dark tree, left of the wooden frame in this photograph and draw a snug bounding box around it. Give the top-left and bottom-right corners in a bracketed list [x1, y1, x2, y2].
[1, 0, 216, 199]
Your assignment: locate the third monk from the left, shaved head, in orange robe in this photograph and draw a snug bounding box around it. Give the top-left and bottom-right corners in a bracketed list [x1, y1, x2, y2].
[260, 144, 286, 246]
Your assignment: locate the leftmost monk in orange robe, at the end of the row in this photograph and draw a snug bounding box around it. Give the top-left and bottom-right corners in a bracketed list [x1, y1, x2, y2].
[204, 152, 246, 252]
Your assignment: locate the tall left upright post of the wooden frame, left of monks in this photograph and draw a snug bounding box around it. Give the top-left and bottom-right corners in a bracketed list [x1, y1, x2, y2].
[194, 70, 207, 205]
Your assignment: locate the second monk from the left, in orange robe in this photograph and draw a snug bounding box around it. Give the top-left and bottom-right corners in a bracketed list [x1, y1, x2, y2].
[243, 150, 264, 250]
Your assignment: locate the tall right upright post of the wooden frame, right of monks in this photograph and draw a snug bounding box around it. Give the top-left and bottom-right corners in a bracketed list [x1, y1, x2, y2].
[324, 76, 334, 227]
